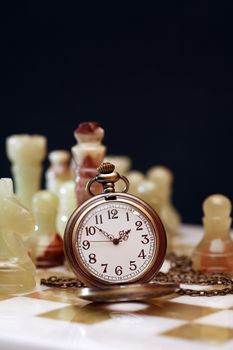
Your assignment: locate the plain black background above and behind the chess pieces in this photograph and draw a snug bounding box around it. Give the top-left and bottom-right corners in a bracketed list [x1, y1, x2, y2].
[0, 1, 233, 223]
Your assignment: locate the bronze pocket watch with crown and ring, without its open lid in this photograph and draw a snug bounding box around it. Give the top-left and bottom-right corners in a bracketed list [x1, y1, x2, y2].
[64, 163, 166, 288]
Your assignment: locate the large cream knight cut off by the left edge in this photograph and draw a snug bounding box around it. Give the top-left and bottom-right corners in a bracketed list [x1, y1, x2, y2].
[0, 179, 36, 294]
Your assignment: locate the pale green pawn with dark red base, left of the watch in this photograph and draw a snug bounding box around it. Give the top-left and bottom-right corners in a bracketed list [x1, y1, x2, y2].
[32, 190, 64, 267]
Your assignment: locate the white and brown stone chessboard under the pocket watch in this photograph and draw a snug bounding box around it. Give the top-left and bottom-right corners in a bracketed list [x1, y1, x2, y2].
[0, 226, 233, 350]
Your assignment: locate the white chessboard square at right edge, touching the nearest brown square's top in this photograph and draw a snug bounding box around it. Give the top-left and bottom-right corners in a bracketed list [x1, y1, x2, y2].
[195, 310, 233, 328]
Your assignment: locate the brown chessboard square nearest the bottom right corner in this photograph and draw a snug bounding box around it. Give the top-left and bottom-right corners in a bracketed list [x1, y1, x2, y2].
[160, 323, 233, 345]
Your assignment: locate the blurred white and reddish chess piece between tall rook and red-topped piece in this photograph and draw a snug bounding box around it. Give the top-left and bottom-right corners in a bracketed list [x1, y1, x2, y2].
[45, 150, 73, 195]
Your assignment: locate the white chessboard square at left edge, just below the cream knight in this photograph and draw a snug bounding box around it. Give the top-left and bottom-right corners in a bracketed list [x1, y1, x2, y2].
[0, 297, 67, 318]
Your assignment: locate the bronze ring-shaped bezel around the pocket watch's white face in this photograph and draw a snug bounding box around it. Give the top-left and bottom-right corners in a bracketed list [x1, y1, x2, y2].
[64, 192, 167, 287]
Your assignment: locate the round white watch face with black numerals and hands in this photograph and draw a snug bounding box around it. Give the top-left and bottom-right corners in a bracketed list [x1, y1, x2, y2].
[76, 202, 157, 283]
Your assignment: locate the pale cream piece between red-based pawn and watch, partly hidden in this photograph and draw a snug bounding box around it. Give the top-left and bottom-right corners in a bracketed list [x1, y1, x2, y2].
[57, 181, 77, 237]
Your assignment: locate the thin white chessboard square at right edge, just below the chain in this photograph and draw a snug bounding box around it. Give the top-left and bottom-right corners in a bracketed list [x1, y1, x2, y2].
[171, 295, 233, 309]
